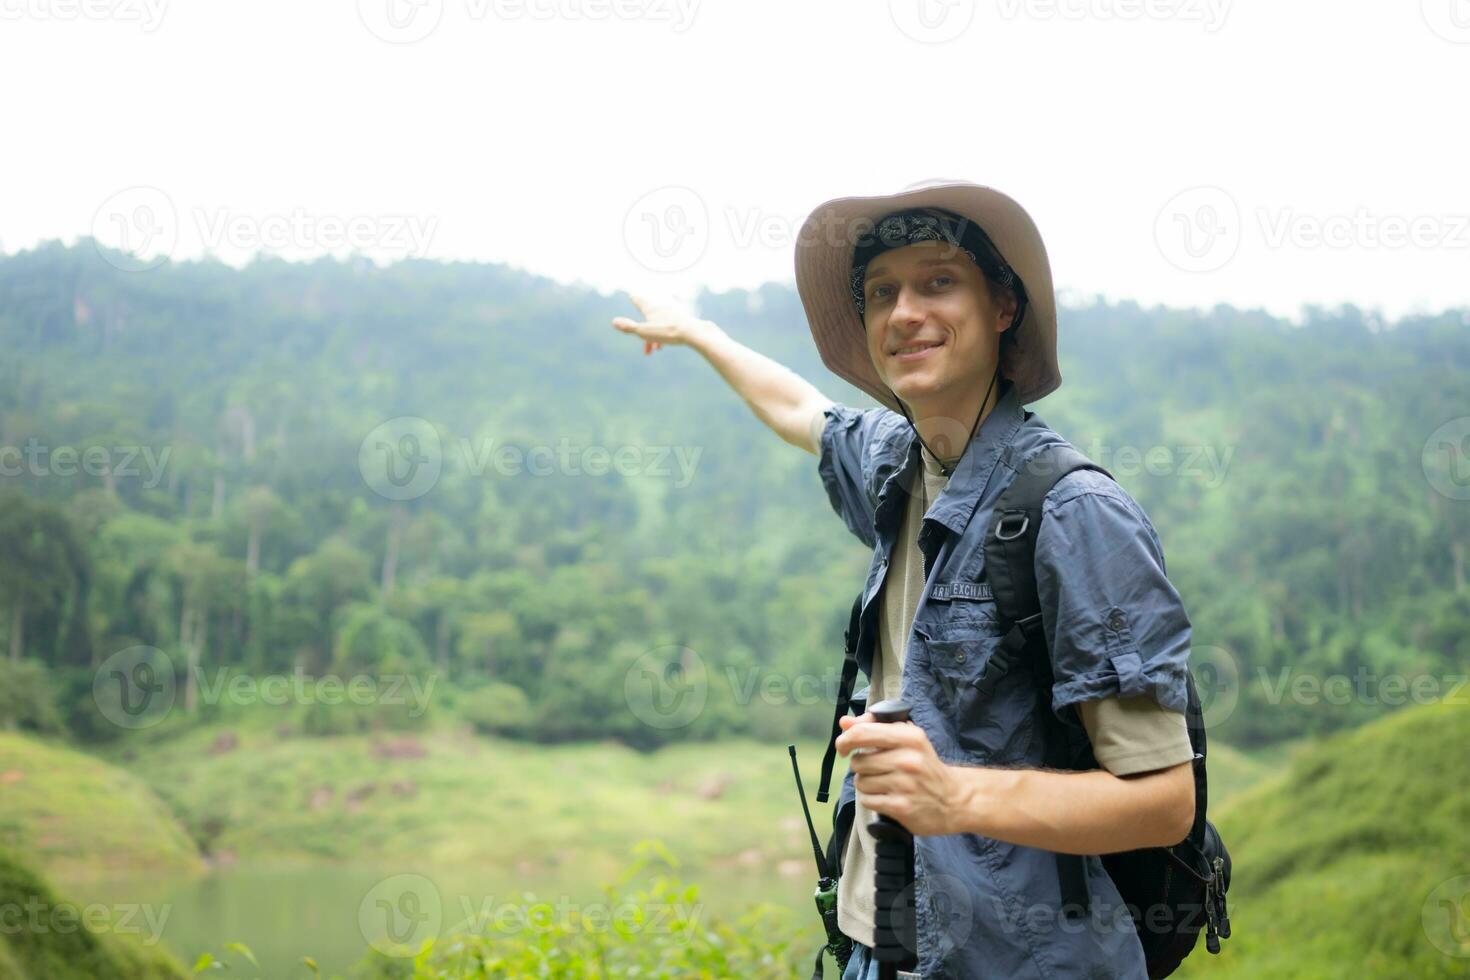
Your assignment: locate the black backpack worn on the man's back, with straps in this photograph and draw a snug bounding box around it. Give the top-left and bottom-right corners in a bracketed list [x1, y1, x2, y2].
[814, 443, 1230, 980]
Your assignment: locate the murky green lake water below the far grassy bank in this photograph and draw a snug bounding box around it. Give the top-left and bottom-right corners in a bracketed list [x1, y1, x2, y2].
[65, 865, 817, 980]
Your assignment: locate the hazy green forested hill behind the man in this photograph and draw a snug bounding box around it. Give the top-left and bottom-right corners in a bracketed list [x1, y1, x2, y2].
[0, 241, 1470, 745]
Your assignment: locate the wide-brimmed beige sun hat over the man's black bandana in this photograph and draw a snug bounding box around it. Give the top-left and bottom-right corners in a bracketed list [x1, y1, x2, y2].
[797, 181, 1061, 411]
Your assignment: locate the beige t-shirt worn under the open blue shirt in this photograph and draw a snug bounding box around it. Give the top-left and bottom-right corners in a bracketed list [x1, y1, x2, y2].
[836, 450, 1194, 946]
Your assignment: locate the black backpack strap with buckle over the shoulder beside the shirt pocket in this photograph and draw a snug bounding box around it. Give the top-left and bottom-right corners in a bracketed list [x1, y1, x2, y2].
[979, 445, 1113, 918]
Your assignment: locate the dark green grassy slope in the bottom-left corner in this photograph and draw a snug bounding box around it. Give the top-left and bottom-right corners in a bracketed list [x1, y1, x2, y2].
[0, 849, 187, 980]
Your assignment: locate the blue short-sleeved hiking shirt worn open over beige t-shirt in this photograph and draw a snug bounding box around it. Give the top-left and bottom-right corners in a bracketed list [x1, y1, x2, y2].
[819, 381, 1191, 980]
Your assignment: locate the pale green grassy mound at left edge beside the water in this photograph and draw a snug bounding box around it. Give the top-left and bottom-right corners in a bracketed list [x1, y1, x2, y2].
[0, 733, 203, 877]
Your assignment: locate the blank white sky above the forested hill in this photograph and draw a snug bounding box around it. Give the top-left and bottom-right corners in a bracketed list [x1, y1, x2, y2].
[0, 0, 1470, 316]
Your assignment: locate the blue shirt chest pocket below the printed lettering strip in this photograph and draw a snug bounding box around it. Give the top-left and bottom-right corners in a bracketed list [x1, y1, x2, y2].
[914, 614, 1038, 763]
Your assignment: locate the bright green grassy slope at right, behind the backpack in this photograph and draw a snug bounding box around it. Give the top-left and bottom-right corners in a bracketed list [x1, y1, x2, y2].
[1180, 704, 1470, 980]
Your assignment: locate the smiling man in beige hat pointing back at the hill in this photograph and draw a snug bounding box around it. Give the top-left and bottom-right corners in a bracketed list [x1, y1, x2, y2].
[613, 181, 1194, 980]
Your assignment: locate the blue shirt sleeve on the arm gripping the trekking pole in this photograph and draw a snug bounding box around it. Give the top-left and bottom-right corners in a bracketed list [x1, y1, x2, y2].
[1036, 472, 1191, 721]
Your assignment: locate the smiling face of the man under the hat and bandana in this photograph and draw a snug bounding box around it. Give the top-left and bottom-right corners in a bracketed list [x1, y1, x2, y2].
[863, 241, 1014, 417]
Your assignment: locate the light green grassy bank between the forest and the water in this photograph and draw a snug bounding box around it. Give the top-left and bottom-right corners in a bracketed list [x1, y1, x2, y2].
[114, 727, 1267, 874]
